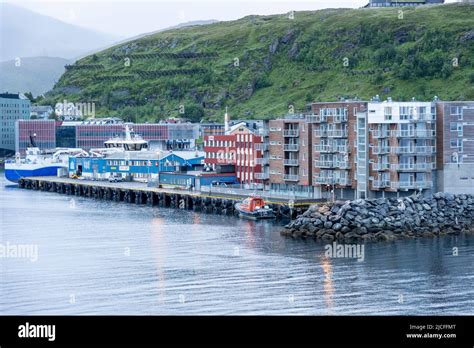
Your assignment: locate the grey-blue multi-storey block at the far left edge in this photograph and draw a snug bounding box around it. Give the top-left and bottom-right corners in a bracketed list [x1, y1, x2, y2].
[0, 93, 31, 156]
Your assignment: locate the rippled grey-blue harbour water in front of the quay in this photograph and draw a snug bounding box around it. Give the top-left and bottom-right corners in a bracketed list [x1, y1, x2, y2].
[0, 177, 474, 315]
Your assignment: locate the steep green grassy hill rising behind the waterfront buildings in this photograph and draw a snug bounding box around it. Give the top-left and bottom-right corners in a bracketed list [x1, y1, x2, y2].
[43, 4, 474, 121]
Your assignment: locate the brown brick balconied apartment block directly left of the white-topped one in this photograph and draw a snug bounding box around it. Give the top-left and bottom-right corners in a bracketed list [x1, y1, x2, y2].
[308, 101, 367, 199]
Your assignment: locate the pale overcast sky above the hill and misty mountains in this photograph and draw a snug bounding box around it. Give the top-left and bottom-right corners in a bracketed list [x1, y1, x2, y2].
[0, 0, 455, 38]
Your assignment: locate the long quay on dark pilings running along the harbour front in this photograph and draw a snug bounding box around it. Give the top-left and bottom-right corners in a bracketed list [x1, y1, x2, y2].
[18, 176, 325, 219]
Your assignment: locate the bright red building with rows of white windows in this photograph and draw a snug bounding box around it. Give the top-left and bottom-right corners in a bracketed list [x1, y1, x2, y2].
[204, 125, 268, 185]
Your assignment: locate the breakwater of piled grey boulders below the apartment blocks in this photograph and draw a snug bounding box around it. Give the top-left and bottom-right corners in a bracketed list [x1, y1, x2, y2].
[281, 193, 474, 241]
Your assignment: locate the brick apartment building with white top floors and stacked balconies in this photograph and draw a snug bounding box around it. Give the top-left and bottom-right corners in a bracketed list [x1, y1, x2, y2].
[367, 100, 436, 197]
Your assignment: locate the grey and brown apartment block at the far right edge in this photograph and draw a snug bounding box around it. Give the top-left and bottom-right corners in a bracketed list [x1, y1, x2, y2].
[436, 101, 474, 194]
